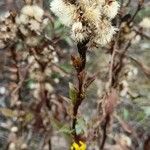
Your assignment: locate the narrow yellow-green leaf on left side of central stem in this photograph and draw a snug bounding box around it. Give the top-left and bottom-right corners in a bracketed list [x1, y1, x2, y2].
[69, 83, 78, 104]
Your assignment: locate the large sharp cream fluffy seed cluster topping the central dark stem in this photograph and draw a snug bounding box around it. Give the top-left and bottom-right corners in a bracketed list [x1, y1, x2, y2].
[50, 0, 119, 47]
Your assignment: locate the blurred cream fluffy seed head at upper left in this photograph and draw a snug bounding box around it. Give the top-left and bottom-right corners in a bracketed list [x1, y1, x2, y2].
[15, 5, 46, 35]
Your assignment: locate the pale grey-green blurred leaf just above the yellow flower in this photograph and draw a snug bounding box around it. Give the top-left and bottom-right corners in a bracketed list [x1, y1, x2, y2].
[75, 118, 87, 135]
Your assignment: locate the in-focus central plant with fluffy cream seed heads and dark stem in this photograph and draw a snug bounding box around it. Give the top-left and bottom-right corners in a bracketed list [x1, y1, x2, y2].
[50, 0, 119, 149]
